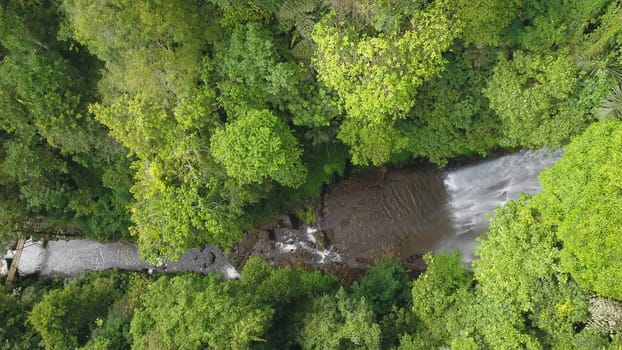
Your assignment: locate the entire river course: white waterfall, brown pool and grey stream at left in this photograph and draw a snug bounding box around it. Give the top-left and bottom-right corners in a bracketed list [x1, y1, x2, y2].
[3, 151, 561, 278]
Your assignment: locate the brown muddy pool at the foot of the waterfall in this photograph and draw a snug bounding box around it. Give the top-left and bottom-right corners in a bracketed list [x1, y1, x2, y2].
[322, 167, 452, 268]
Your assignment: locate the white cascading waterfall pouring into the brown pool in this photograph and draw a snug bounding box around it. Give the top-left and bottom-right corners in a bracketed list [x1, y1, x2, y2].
[435, 150, 562, 263]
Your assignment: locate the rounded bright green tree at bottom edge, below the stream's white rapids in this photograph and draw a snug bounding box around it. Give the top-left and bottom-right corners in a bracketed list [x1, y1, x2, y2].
[130, 274, 272, 349]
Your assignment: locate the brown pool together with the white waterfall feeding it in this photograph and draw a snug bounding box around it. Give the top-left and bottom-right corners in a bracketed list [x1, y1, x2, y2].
[322, 151, 562, 268]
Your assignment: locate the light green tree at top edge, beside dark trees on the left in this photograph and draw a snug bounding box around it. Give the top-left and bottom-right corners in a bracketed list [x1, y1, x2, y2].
[63, 0, 213, 104]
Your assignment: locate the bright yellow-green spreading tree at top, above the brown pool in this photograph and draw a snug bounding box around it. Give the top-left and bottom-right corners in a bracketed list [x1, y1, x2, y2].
[313, 3, 456, 164]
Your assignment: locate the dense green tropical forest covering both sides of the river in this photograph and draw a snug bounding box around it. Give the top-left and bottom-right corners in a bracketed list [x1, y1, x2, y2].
[0, 0, 622, 350]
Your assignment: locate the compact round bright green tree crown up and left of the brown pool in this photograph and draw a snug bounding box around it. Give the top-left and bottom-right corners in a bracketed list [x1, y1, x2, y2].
[211, 110, 307, 187]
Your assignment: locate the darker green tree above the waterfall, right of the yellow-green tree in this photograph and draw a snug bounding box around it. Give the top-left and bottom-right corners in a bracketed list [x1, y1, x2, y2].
[404, 44, 500, 165]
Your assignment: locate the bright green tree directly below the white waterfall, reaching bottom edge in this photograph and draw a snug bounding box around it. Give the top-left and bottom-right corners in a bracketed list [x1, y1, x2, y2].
[473, 196, 588, 349]
